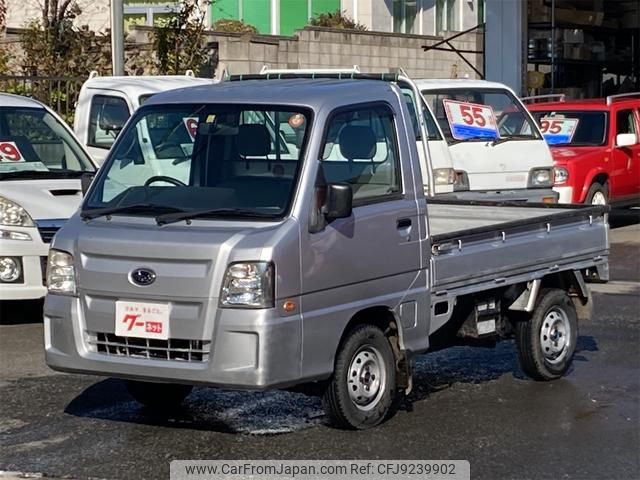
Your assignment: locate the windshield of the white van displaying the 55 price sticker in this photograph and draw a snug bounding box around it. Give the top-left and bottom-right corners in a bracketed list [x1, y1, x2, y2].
[422, 88, 540, 144]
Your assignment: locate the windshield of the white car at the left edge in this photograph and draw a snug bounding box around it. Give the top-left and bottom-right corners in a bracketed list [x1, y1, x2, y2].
[0, 107, 95, 179]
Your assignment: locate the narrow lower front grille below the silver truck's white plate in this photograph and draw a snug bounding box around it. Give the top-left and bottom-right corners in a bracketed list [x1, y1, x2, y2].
[87, 332, 211, 362]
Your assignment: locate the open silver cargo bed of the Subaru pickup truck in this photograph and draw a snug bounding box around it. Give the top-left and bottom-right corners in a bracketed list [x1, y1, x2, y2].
[427, 200, 608, 296]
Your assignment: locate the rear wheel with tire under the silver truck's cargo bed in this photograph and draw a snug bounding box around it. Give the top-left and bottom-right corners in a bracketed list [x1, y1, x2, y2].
[516, 288, 578, 380]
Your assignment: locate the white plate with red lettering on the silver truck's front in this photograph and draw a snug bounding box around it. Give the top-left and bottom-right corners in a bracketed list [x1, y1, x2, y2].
[116, 301, 169, 340]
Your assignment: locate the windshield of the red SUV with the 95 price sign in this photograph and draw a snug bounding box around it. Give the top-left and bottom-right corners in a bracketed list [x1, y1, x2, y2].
[531, 110, 607, 147]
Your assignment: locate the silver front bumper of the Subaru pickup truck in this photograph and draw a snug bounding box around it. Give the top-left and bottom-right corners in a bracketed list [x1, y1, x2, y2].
[44, 294, 302, 390]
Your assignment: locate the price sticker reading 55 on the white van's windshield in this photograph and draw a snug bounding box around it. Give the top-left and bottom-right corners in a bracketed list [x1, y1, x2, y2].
[442, 100, 499, 140]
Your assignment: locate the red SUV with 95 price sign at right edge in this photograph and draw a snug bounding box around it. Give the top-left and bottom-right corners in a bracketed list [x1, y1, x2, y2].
[527, 93, 640, 206]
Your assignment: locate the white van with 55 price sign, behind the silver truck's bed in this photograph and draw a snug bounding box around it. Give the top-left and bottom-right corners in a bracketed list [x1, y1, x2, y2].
[415, 79, 558, 203]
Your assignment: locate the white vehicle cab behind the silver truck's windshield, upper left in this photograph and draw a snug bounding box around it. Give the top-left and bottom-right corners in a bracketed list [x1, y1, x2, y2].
[73, 71, 217, 165]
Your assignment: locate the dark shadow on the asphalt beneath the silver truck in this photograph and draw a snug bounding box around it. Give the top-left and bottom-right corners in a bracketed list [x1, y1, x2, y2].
[65, 336, 598, 435]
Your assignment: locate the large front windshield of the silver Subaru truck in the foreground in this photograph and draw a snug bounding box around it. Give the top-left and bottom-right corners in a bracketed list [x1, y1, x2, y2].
[84, 104, 309, 218]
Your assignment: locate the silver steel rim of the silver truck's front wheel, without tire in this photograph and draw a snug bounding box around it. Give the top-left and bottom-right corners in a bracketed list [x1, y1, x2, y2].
[347, 346, 386, 410]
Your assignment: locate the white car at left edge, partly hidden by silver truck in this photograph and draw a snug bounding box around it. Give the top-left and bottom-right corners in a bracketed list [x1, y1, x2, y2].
[0, 93, 96, 300]
